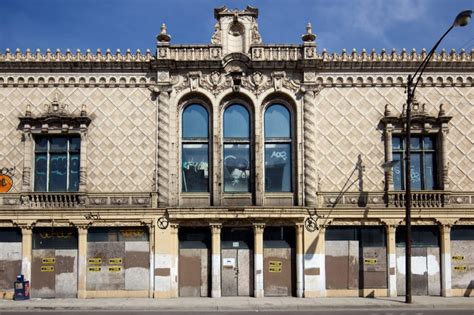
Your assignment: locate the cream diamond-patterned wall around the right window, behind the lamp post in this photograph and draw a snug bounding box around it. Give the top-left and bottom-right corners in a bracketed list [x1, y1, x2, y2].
[315, 87, 474, 191]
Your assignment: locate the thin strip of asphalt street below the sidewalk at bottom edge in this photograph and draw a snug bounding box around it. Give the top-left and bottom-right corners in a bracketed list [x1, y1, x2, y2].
[0, 308, 474, 315]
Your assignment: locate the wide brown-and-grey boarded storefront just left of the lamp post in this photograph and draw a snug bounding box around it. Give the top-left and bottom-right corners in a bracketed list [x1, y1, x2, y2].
[325, 226, 387, 295]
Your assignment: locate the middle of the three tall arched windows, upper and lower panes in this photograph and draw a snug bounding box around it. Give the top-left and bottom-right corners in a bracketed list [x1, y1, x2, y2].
[224, 104, 251, 192]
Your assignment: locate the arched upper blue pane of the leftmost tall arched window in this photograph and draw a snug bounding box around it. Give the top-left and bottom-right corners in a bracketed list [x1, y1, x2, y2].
[183, 104, 209, 138]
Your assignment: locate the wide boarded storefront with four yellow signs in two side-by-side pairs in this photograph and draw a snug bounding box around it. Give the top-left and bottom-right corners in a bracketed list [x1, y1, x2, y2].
[86, 227, 150, 294]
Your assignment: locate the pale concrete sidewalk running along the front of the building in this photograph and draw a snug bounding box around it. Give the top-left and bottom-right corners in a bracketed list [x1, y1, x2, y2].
[0, 296, 474, 311]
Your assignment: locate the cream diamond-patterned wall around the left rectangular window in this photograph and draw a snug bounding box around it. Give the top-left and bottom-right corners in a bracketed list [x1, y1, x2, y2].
[0, 87, 156, 192]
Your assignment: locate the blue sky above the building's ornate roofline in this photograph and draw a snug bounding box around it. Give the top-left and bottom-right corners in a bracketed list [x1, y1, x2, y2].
[0, 0, 474, 53]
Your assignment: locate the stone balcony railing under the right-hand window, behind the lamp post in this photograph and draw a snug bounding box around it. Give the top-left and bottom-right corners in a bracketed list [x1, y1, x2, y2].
[387, 191, 449, 208]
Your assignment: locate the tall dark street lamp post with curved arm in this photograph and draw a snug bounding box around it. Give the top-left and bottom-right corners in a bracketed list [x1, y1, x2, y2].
[405, 10, 472, 303]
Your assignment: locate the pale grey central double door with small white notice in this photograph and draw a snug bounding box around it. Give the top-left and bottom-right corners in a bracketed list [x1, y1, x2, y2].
[221, 249, 253, 296]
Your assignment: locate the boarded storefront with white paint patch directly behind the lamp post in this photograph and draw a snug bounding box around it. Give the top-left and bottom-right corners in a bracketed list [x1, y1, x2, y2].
[396, 226, 441, 296]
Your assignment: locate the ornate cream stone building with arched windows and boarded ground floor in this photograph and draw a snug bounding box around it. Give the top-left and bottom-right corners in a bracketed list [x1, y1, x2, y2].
[0, 7, 474, 298]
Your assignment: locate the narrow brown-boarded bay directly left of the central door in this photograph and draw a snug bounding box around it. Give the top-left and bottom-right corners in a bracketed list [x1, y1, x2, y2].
[178, 227, 211, 297]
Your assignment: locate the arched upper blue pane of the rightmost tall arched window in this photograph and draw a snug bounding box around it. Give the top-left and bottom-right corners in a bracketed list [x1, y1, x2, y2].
[265, 104, 291, 139]
